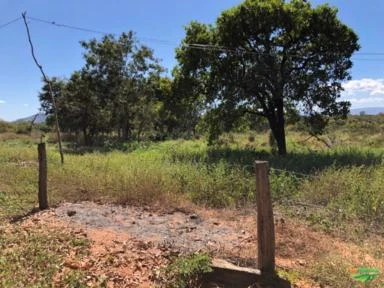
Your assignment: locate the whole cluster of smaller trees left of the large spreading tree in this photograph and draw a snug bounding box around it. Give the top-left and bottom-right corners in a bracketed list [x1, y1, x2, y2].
[39, 32, 203, 145]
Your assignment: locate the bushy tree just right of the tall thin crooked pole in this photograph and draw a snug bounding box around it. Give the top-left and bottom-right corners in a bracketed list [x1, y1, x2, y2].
[40, 32, 167, 145]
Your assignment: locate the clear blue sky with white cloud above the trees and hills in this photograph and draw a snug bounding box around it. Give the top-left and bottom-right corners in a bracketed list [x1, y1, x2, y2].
[0, 0, 384, 121]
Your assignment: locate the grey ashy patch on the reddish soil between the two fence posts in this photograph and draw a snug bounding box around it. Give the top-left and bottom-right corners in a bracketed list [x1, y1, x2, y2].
[55, 202, 249, 252]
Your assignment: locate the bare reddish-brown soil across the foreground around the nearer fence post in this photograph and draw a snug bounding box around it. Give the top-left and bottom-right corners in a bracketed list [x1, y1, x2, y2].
[15, 202, 384, 288]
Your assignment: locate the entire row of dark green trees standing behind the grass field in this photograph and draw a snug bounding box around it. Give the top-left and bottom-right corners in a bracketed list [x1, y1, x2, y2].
[40, 0, 360, 155]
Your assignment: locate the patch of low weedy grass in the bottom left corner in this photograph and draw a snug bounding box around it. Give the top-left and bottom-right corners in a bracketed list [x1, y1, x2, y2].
[0, 224, 88, 287]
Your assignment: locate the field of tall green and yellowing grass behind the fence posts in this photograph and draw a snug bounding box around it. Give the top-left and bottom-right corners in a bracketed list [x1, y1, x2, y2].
[0, 116, 384, 287]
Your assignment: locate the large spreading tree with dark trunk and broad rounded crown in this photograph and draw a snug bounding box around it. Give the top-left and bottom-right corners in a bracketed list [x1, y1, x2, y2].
[177, 0, 359, 154]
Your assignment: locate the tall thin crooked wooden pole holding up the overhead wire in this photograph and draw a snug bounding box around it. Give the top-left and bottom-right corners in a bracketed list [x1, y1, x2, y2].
[21, 12, 64, 165]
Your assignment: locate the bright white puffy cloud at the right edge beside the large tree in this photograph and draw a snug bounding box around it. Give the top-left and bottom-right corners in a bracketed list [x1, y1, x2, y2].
[343, 78, 384, 96]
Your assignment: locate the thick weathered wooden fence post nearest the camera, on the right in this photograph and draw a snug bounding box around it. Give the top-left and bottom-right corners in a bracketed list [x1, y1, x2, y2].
[255, 161, 275, 274]
